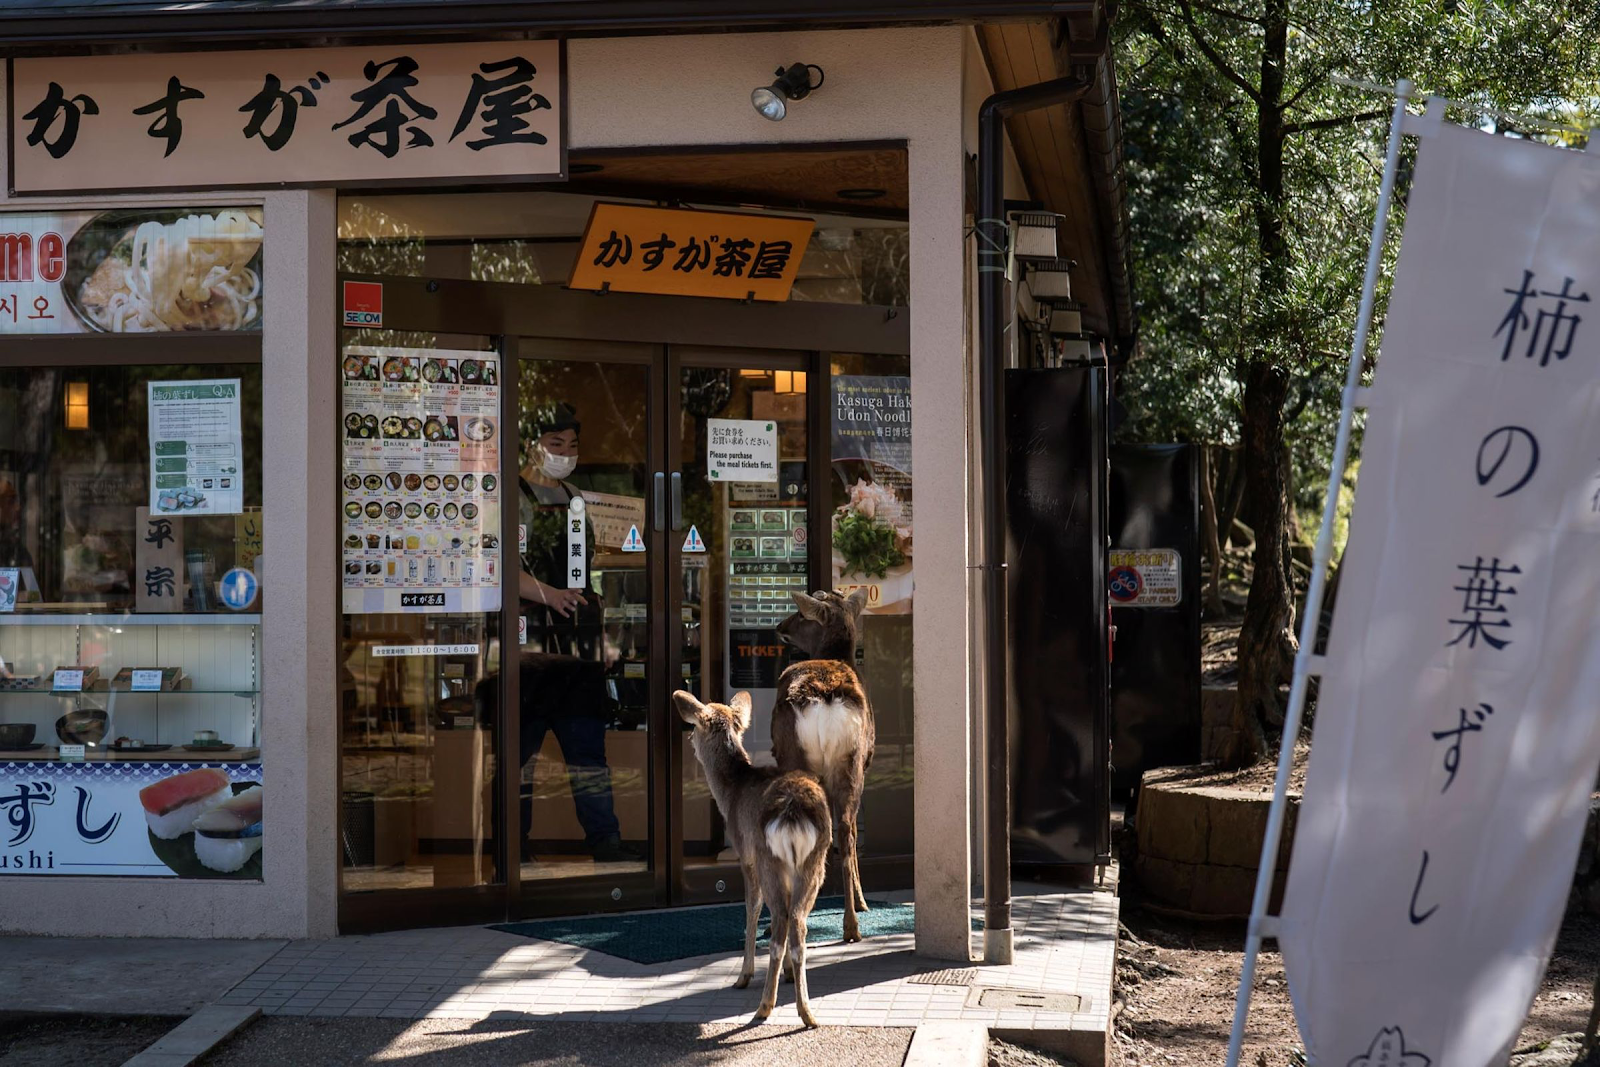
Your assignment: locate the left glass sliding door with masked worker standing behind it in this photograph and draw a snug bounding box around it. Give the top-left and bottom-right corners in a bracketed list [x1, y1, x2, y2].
[507, 339, 666, 910]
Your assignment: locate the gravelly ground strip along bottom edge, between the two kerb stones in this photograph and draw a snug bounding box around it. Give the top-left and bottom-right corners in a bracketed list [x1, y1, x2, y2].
[203, 1016, 912, 1067]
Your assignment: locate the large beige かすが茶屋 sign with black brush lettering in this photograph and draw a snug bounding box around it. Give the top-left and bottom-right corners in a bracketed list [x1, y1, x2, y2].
[10, 40, 566, 194]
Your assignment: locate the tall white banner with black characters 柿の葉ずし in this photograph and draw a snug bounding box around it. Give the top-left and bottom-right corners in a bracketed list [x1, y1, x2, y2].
[1278, 125, 1600, 1067]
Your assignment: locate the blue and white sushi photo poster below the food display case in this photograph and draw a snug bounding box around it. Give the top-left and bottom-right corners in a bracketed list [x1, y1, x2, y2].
[0, 760, 262, 880]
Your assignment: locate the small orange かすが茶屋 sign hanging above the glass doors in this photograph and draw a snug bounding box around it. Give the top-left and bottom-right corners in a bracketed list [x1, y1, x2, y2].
[566, 203, 816, 302]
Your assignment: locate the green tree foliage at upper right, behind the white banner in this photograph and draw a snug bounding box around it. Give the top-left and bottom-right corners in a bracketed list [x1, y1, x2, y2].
[1117, 0, 1600, 512]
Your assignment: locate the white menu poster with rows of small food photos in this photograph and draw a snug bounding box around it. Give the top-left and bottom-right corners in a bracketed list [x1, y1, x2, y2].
[341, 347, 501, 614]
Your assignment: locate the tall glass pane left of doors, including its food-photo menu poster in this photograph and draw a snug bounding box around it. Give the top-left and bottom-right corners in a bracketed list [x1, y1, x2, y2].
[339, 330, 506, 893]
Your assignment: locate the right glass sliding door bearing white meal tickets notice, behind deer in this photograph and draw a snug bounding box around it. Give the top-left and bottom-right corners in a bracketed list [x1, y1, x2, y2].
[667, 347, 813, 901]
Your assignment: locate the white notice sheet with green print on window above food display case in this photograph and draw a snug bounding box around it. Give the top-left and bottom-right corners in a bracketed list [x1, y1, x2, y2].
[149, 378, 245, 515]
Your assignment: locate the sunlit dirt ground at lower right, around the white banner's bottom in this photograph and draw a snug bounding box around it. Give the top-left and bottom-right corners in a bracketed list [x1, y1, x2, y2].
[1114, 902, 1600, 1067]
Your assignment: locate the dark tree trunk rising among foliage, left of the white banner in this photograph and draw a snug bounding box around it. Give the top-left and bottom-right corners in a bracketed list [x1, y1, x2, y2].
[1226, 0, 1294, 766]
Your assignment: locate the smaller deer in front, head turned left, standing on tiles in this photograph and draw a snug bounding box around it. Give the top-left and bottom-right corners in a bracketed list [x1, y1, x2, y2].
[672, 689, 834, 1027]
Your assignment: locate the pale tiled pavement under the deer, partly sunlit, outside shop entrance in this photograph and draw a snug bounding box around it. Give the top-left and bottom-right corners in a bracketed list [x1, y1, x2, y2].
[219, 891, 1118, 1033]
